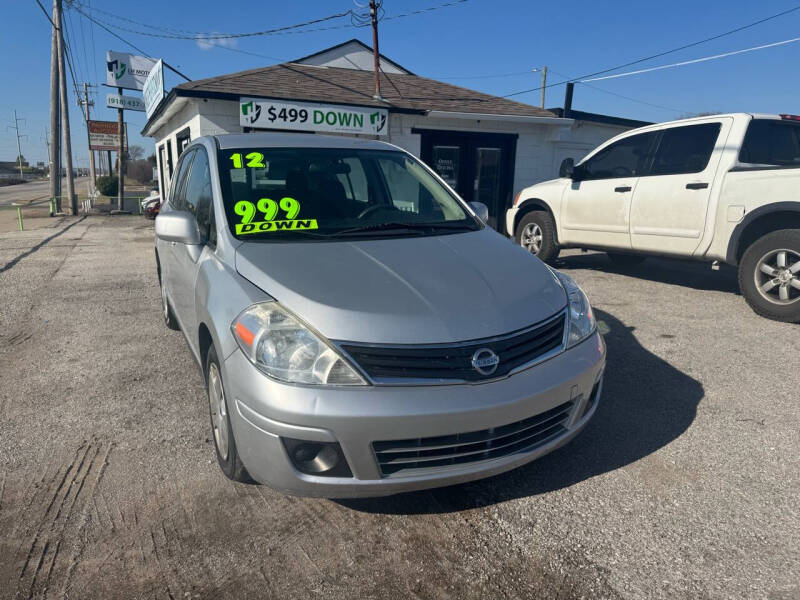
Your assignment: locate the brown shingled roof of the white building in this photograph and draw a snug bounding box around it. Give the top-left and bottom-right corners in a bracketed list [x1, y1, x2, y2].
[169, 63, 556, 117]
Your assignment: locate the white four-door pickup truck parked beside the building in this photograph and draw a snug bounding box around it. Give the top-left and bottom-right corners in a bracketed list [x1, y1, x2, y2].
[506, 113, 800, 323]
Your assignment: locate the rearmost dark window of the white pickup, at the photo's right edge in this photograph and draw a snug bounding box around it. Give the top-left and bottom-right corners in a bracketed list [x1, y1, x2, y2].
[739, 119, 800, 166]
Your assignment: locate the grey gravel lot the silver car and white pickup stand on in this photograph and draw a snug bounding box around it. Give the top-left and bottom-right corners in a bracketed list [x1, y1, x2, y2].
[0, 217, 800, 600]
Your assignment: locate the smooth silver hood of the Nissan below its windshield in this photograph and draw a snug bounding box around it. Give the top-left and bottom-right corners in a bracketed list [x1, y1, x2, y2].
[236, 228, 566, 344]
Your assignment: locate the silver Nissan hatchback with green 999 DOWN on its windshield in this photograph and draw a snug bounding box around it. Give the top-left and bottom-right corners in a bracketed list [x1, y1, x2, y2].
[156, 133, 605, 497]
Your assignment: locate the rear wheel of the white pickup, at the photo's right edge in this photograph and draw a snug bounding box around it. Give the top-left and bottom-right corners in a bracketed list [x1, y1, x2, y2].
[739, 229, 800, 323]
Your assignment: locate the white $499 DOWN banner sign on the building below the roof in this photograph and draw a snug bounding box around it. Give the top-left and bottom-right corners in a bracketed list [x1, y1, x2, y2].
[239, 98, 389, 135]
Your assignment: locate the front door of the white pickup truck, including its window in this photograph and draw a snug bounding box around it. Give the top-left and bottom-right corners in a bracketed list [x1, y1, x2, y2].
[560, 132, 656, 248]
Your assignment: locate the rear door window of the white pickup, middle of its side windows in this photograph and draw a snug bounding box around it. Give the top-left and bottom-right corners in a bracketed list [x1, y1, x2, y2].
[650, 123, 722, 175]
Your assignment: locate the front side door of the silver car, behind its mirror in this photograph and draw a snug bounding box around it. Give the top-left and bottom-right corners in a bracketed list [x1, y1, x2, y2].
[172, 146, 212, 339]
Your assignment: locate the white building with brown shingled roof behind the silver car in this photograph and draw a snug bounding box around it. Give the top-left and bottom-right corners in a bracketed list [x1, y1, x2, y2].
[142, 40, 645, 231]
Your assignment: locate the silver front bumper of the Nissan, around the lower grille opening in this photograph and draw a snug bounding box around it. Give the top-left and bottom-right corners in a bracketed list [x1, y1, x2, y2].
[223, 333, 605, 498]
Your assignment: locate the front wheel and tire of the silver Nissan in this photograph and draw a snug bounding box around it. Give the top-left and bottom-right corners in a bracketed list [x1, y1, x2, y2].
[204, 344, 252, 482]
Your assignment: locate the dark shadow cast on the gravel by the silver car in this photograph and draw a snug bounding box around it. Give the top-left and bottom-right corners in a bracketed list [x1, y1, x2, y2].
[338, 310, 704, 514]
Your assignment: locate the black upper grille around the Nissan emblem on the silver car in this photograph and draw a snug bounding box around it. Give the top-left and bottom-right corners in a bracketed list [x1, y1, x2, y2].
[341, 313, 566, 383]
